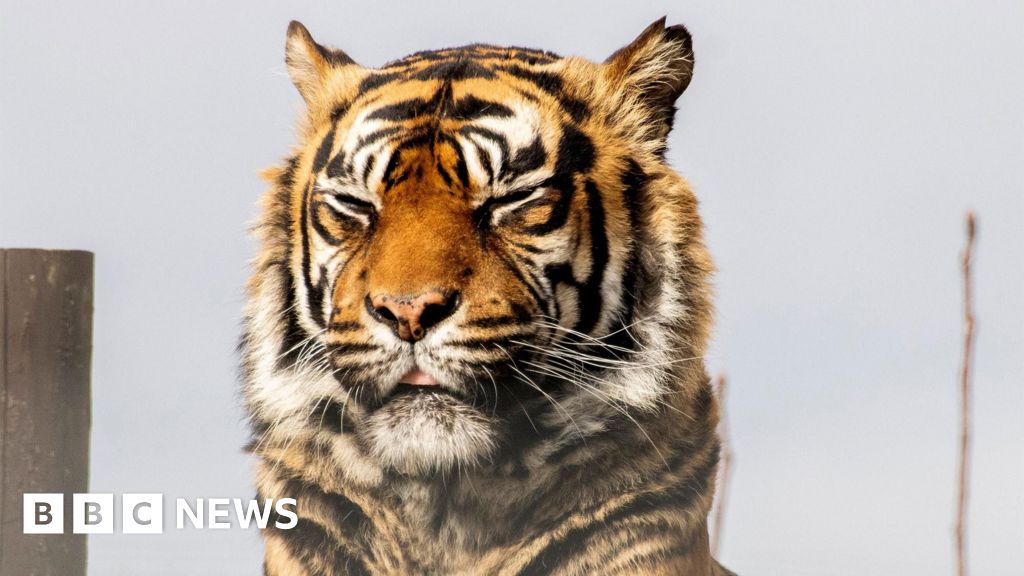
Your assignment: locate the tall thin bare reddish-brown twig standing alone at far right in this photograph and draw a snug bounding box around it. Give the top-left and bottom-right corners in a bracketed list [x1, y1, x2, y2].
[955, 210, 975, 576]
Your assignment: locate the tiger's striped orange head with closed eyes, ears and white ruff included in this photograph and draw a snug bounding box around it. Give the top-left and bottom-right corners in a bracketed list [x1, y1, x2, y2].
[243, 19, 711, 475]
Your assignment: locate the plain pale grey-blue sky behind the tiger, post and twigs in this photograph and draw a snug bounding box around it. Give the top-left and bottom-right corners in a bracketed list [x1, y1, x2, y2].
[0, 0, 1024, 576]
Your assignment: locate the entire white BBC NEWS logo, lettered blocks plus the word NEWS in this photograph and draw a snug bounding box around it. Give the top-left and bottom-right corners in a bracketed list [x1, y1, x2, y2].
[22, 493, 299, 534]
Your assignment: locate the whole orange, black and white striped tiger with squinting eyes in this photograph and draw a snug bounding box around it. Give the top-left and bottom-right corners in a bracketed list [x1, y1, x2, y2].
[240, 18, 731, 576]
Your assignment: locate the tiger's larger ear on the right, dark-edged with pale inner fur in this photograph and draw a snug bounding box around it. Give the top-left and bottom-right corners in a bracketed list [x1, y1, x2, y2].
[604, 17, 693, 153]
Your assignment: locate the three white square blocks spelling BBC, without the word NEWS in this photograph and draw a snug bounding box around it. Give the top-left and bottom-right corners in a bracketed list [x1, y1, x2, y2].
[22, 493, 164, 534]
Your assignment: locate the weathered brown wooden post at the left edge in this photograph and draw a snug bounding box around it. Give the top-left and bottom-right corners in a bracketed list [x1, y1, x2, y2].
[0, 249, 93, 576]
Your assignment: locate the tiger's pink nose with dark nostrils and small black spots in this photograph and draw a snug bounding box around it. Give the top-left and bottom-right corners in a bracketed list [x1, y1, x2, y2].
[367, 290, 459, 342]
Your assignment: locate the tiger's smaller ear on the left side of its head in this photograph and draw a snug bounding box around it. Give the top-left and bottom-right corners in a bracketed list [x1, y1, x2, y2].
[285, 20, 360, 108]
